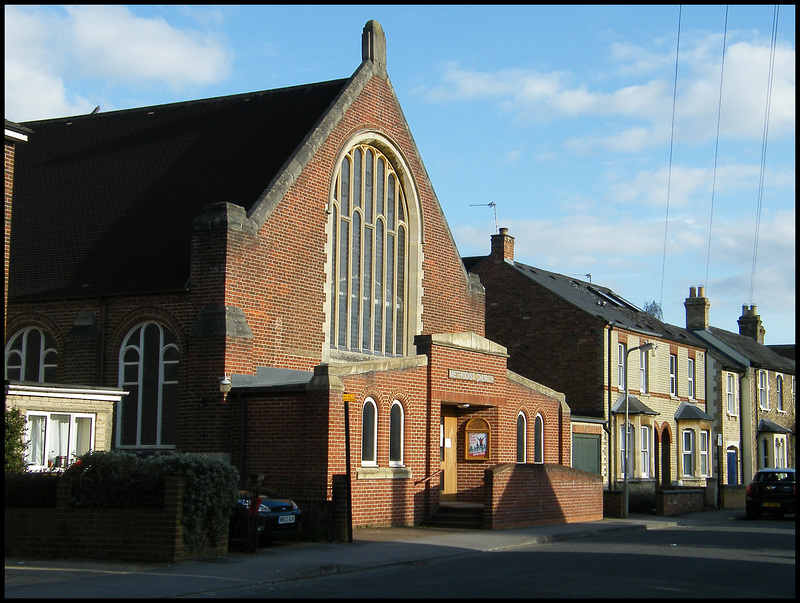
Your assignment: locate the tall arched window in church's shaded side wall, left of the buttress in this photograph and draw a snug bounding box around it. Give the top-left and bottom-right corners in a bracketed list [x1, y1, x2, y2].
[117, 322, 180, 447]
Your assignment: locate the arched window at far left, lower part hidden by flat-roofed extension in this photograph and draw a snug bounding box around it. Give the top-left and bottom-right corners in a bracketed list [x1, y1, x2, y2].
[6, 327, 58, 383]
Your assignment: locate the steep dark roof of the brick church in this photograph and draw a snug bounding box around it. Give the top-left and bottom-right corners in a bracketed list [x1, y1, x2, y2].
[9, 79, 349, 301]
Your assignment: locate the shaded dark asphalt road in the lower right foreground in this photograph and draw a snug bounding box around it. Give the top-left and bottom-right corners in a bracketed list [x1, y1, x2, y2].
[216, 516, 796, 599]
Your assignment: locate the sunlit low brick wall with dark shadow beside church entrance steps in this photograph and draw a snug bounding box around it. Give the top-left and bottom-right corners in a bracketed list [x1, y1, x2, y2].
[484, 463, 603, 529]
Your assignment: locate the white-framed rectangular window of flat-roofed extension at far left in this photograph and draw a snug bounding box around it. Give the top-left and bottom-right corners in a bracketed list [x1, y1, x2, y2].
[25, 411, 95, 471]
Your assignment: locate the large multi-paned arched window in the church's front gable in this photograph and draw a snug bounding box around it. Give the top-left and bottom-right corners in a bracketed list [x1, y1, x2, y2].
[330, 144, 409, 356]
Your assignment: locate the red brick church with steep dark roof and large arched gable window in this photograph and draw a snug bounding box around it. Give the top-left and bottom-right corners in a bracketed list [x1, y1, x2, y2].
[6, 21, 602, 538]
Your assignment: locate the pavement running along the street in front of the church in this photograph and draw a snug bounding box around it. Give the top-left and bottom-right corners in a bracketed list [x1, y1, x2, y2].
[5, 509, 744, 599]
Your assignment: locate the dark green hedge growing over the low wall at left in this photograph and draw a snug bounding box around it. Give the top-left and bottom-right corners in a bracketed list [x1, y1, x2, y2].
[65, 450, 239, 551]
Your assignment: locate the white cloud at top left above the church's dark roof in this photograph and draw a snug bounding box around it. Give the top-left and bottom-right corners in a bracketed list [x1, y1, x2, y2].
[5, 6, 233, 121]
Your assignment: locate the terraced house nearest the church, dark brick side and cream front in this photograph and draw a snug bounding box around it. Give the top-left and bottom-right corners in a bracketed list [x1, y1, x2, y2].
[463, 228, 716, 514]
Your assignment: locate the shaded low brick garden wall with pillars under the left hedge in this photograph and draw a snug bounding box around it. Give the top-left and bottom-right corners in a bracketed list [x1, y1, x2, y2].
[5, 477, 228, 562]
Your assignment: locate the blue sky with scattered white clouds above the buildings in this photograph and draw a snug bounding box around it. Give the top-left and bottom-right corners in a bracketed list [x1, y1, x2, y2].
[5, 5, 796, 344]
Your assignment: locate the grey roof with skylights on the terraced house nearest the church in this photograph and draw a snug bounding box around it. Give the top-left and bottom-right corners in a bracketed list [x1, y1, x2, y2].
[462, 256, 705, 348]
